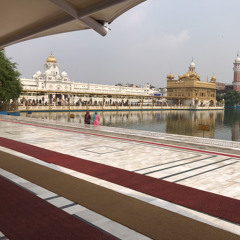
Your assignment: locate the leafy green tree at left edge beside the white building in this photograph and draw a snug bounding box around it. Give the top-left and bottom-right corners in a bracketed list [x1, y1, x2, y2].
[0, 50, 22, 110]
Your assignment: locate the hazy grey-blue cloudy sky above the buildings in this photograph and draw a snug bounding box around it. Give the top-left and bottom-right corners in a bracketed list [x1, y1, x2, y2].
[6, 0, 240, 87]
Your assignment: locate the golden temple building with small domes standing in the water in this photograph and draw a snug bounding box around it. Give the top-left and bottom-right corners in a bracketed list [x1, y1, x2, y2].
[167, 61, 216, 107]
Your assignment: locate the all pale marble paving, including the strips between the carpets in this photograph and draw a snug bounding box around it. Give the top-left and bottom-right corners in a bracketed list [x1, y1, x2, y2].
[0, 115, 240, 239]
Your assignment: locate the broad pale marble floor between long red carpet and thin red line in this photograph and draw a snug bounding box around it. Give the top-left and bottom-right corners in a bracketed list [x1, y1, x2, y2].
[0, 119, 240, 200]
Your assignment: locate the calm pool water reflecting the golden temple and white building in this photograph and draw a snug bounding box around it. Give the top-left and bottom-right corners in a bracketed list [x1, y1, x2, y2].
[22, 109, 240, 141]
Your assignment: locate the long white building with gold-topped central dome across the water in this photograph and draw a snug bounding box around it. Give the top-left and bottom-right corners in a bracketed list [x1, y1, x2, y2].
[21, 54, 158, 97]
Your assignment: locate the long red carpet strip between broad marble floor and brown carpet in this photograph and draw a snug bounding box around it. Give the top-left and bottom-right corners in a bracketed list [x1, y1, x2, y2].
[0, 137, 240, 224]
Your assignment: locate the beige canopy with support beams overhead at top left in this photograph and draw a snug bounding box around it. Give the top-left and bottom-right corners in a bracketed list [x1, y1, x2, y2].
[0, 0, 145, 48]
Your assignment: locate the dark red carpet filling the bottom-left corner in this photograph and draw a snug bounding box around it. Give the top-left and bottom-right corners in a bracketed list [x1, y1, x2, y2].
[0, 174, 117, 240]
